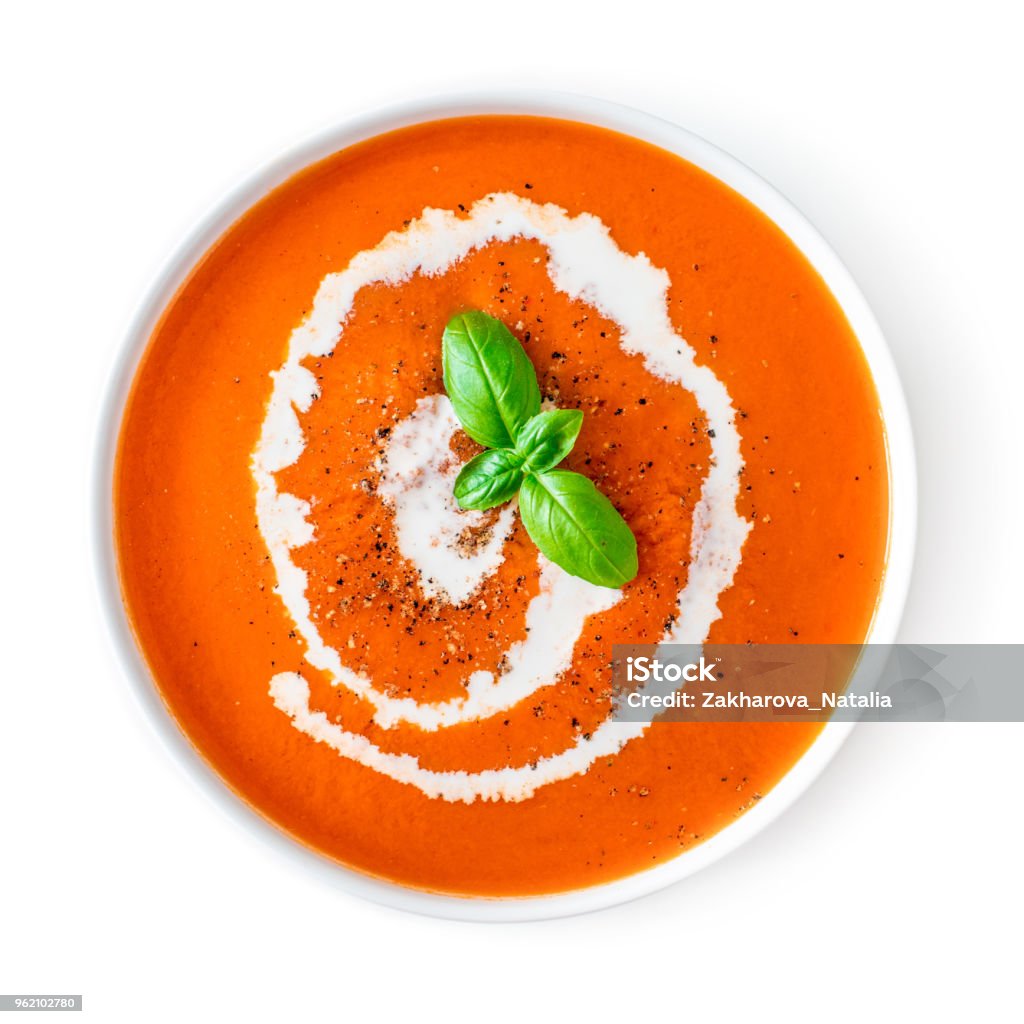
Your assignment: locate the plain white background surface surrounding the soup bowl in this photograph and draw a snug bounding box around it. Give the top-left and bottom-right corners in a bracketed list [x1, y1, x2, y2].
[0, 0, 1024, 1022]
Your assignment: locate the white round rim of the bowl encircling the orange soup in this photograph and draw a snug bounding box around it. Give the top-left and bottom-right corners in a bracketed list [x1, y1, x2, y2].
[90, 89, 916, 922]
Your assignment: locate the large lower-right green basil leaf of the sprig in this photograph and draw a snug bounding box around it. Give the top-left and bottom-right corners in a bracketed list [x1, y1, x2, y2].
[519, 469, 637, 588]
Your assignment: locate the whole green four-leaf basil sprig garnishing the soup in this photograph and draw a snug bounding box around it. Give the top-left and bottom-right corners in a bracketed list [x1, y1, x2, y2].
[442, 310, 637, 589]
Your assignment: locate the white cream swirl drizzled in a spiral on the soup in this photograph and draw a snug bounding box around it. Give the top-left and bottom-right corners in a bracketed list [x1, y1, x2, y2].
[251, 193, 751, 803]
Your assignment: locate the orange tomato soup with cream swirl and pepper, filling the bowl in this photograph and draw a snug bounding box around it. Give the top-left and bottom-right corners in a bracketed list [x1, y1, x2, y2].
[114, 116, 889, 896]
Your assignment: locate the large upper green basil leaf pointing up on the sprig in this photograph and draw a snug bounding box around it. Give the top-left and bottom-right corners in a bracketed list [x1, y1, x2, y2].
[441, 309, 541, 447]
